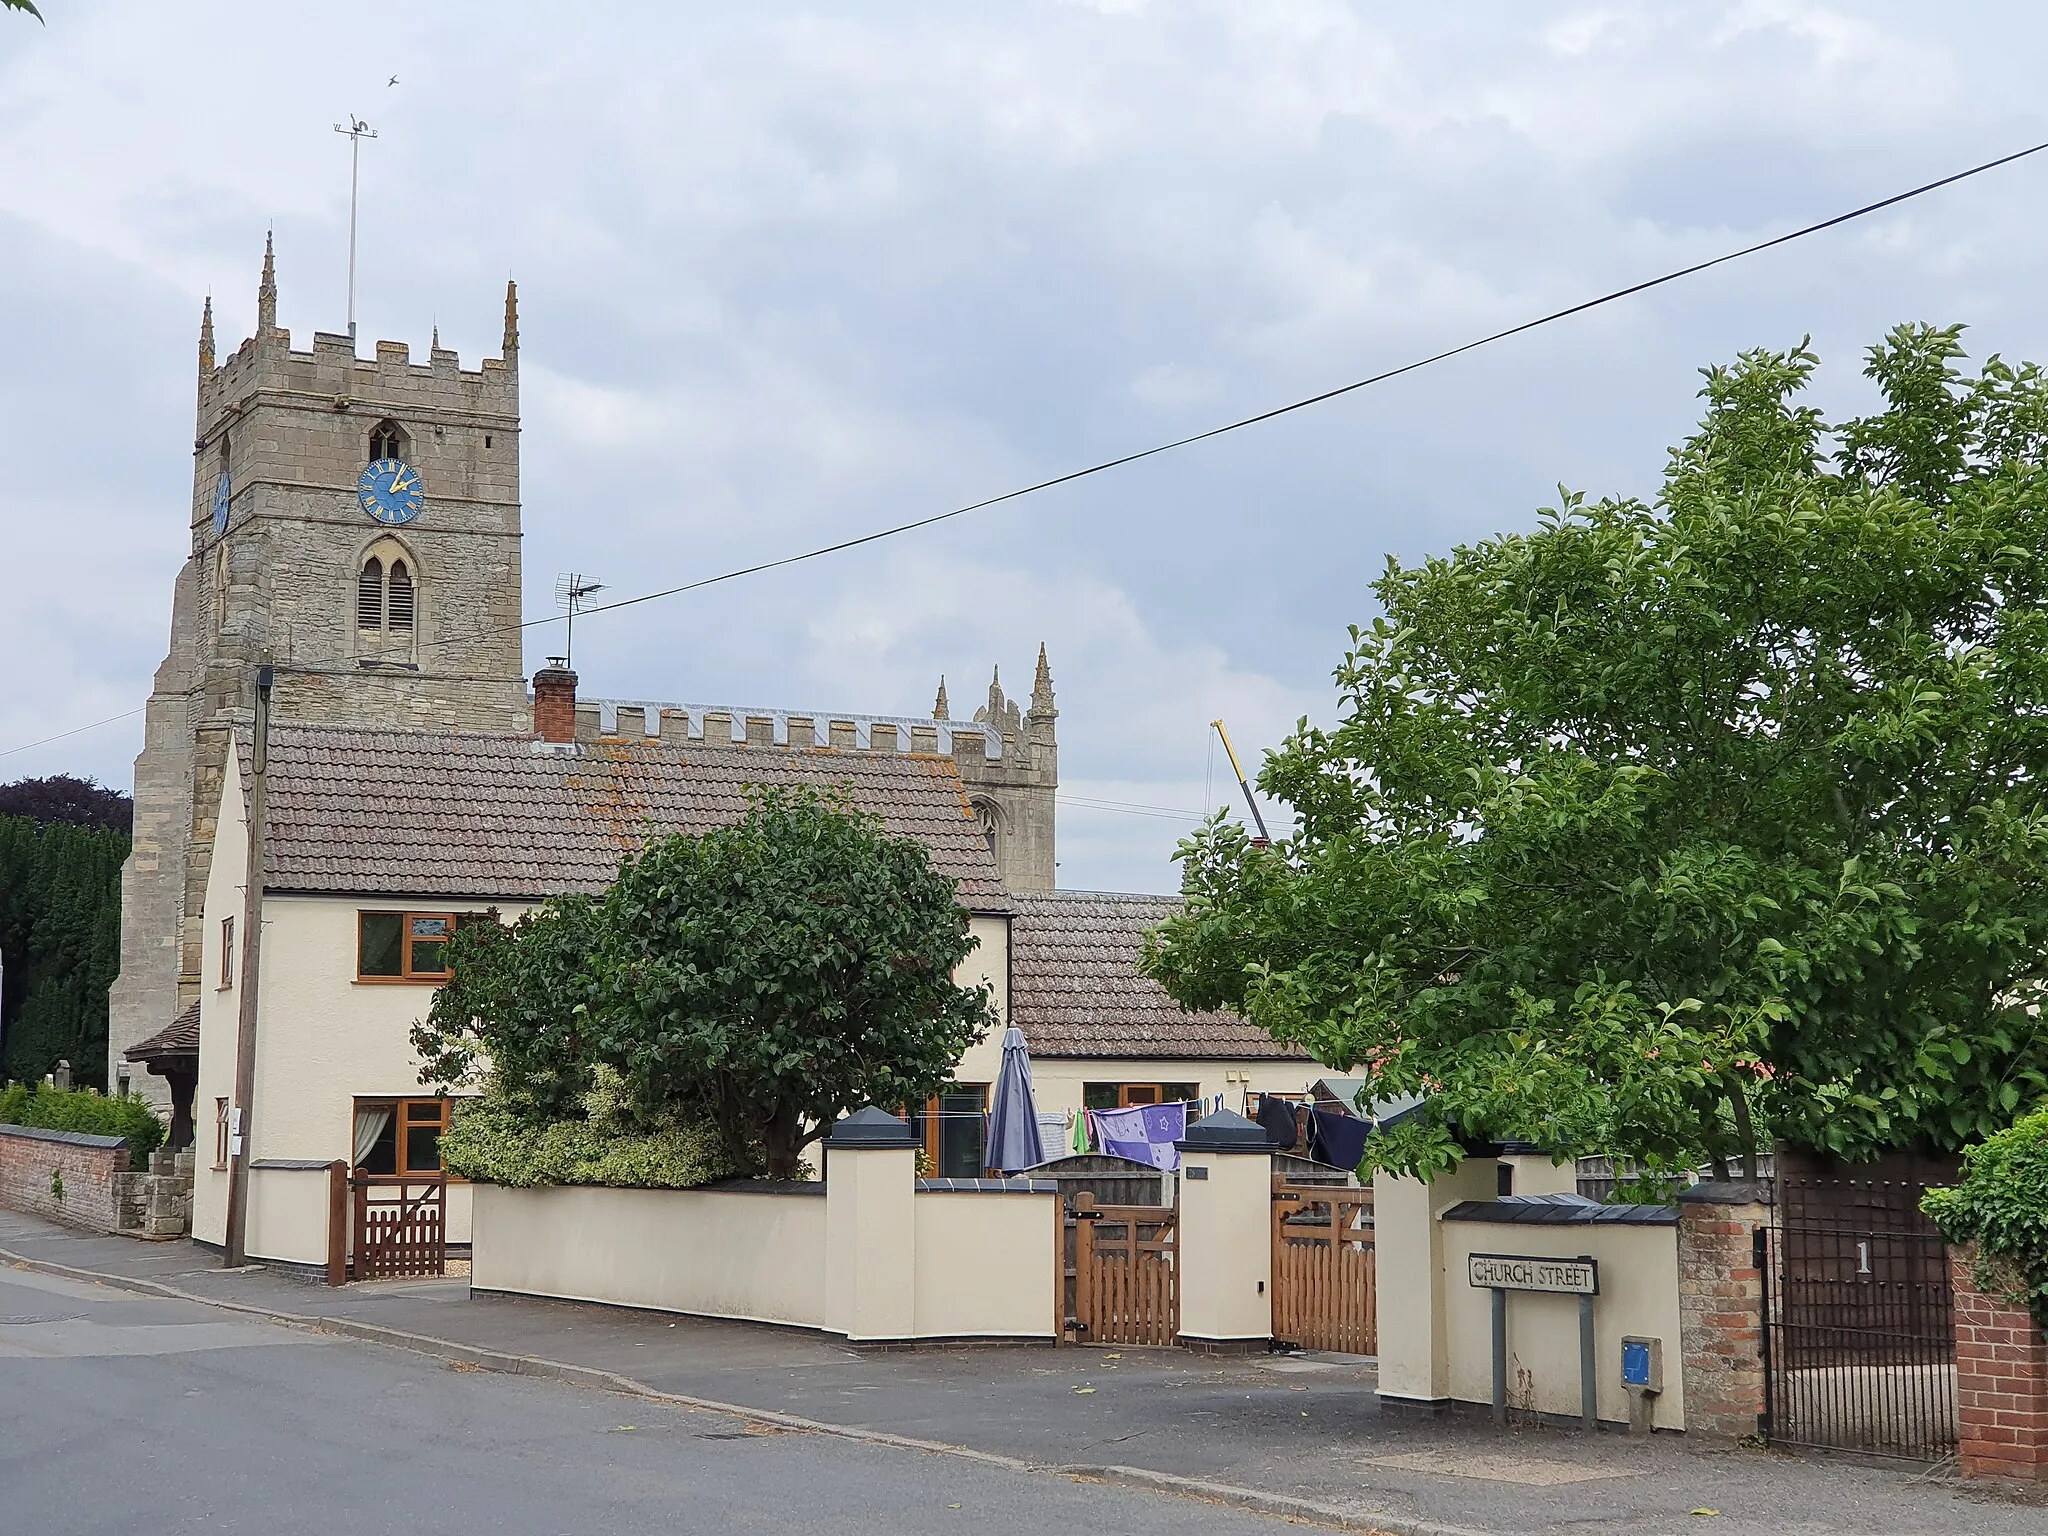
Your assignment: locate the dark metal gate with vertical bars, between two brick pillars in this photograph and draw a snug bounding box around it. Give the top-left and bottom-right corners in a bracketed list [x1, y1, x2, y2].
[1757, 1178, 1956, 1462]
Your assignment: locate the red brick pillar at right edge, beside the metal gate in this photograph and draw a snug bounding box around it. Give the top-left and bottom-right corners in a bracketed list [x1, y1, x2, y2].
[1950, 1247, 2048, 1483]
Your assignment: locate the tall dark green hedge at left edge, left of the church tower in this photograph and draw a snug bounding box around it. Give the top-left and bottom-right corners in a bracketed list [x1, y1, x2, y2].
[0, 811, 130, 1083]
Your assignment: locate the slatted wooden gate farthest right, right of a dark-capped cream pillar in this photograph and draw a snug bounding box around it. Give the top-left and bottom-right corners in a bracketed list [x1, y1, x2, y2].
[1272, 1178, 1380, 1356]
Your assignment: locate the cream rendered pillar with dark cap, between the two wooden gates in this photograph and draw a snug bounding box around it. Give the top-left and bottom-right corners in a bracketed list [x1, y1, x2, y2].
[1174, 1110, 1274, 1354]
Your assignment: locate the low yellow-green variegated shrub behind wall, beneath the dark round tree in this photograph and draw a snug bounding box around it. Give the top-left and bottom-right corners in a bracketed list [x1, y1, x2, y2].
[440, 1069, 745, 1190]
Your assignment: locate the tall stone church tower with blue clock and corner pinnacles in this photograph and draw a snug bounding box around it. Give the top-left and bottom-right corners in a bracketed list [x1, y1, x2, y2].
[109, 242, 532, 1096]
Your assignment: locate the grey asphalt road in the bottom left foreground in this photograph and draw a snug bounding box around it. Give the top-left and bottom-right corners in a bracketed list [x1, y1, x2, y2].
[0, 1270, 1286, 1536]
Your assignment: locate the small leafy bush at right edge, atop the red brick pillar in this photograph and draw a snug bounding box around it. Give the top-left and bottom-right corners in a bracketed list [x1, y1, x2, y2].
[1921, 1110, 2048, 1329]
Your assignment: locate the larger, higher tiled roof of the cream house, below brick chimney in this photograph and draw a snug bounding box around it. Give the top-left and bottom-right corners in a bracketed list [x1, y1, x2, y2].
[256, 721, 1010, 911]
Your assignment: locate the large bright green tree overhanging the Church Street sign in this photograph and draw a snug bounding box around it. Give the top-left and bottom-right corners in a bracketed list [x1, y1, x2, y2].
[1145, 326, 2048, 1171]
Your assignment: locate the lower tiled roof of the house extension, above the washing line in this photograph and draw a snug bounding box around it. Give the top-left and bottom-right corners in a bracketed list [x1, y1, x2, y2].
[1010, 891, 1309, 1061]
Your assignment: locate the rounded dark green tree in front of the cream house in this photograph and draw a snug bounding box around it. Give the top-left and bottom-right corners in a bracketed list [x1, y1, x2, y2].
[414, 788, 993, 1178]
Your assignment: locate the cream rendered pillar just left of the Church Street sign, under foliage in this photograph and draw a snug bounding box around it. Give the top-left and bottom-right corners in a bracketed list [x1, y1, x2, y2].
[1372, 1157, 1499, 1413]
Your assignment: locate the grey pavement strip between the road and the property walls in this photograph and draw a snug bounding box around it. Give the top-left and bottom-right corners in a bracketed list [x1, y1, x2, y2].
[0, 1212, 2048, 1536]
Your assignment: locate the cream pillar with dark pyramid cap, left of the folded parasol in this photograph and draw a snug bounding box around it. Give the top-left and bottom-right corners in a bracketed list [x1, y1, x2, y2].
[825, 1108, 918, 1341]
